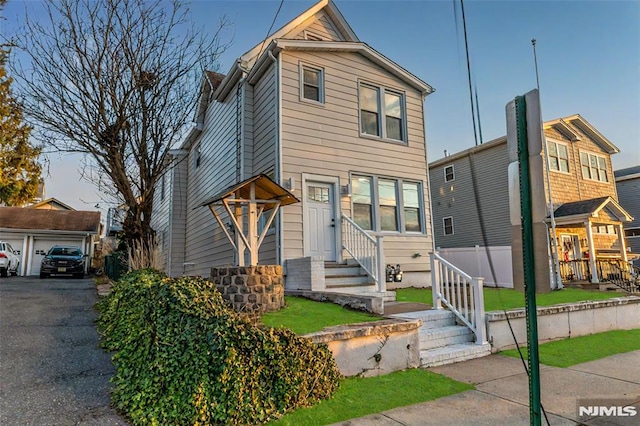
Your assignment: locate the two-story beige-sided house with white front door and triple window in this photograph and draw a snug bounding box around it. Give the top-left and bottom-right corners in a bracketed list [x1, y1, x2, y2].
[153, 0, 433, 296]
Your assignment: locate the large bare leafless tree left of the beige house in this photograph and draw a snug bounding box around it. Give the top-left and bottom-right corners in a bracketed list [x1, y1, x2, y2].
[13, 0, 228, 246]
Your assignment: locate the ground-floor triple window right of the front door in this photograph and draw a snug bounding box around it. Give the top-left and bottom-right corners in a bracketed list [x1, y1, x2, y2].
[351, 176, 424, 233]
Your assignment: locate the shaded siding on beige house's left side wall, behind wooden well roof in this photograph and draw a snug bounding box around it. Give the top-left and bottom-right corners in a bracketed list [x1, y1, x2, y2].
[185, 89, 237, 277]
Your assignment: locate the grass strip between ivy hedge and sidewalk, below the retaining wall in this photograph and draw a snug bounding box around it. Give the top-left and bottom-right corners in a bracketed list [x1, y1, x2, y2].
[270, 369, 474, 426]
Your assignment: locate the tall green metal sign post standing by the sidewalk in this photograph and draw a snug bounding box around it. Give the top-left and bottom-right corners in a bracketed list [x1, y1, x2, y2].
[515, 96, 542, 426]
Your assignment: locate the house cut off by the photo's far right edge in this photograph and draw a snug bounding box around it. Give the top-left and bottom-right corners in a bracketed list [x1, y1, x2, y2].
[614, 166, 640, 267]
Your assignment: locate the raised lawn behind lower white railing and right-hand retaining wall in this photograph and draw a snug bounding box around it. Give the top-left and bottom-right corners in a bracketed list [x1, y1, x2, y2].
[396, 288, 624, 312]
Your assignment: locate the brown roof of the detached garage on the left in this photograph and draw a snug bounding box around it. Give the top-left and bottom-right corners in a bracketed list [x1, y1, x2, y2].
[0, 207, 100, 234]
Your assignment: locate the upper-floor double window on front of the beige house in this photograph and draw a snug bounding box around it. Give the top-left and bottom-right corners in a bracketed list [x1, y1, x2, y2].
[359, 83, 406, 142]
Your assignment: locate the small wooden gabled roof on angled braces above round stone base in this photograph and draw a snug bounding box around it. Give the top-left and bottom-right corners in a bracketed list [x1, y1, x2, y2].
[202, 174, 300, 266]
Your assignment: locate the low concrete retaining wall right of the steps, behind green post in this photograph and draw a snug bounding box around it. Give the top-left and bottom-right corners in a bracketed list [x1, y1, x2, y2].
[486, 296, 640, 352]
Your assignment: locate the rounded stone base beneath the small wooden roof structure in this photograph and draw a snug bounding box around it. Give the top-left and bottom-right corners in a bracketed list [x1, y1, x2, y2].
[210, 265, 284, 313]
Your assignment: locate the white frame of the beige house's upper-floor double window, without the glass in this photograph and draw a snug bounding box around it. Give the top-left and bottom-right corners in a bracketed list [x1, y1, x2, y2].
[358, 80, 409, 145]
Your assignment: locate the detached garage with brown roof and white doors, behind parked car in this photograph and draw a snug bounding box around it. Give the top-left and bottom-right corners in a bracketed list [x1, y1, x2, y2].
[0, 207, 100, 275]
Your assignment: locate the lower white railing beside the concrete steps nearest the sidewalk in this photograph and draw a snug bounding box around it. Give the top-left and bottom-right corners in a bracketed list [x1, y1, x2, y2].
[431, 253, 487, 344]
